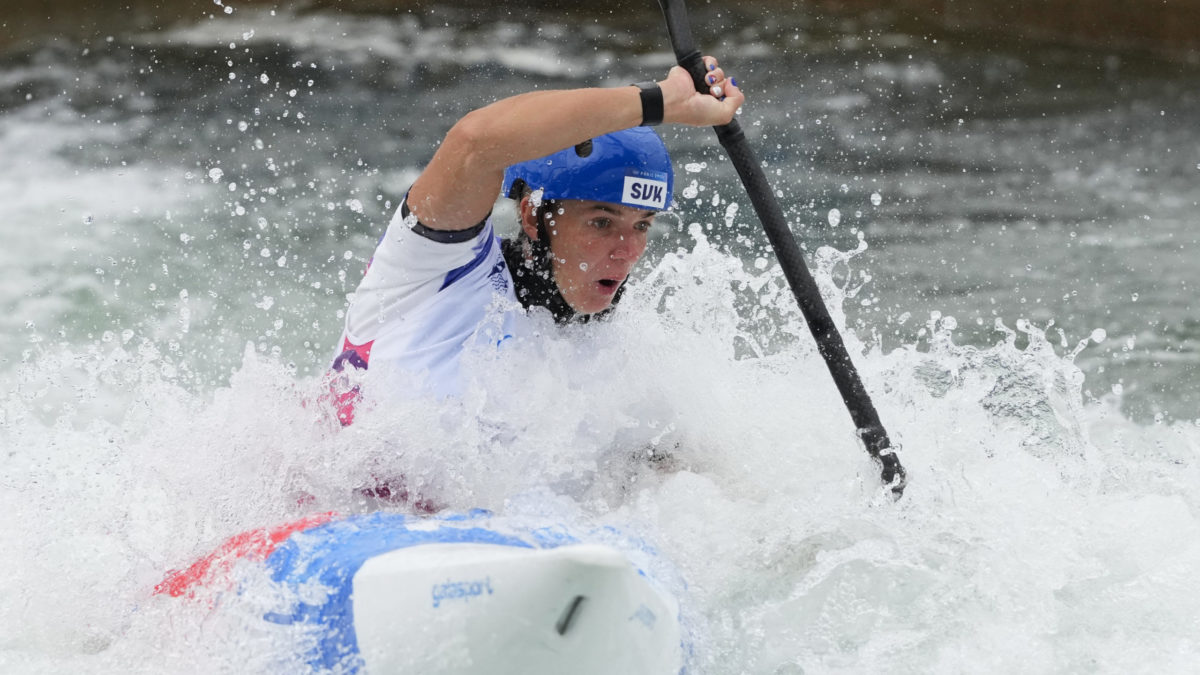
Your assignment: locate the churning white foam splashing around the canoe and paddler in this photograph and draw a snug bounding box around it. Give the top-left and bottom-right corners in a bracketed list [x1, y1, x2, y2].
[0, 222, 1200, 673]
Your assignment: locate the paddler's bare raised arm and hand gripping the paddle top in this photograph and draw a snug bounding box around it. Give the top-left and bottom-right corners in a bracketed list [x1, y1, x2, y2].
[408, 56, 745, 229]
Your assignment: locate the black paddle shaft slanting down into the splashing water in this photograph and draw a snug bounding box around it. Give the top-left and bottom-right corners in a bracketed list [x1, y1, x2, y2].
[659, 0, 905, 498]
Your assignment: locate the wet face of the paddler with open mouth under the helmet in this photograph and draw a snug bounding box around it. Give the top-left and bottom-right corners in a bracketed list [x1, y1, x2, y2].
[522, 199, 655, 313]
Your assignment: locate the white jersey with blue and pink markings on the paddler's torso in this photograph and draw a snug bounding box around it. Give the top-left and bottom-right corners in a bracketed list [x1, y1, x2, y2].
[334, 203, 517, 394]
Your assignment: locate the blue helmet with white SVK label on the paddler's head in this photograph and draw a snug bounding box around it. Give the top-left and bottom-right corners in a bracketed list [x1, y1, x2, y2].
[500, 126, 674, 210]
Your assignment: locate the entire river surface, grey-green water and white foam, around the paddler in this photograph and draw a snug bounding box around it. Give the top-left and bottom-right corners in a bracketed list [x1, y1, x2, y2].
[0, 5, 1200, 674]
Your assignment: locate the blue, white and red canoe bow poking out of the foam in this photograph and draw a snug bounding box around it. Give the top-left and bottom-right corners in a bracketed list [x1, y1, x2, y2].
[156, 512, 684, 675]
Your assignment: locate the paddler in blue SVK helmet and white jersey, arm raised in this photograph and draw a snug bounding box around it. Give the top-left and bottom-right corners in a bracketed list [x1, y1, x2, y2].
[332, 56, 744, 424]
